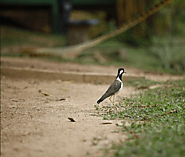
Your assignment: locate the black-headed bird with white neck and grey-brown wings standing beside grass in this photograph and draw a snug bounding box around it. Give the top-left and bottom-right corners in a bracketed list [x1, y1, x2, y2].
[97, 68, 126, 109]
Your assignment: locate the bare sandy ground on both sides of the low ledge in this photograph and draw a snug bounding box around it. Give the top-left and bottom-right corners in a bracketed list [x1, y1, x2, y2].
[1, 58, 184, 157]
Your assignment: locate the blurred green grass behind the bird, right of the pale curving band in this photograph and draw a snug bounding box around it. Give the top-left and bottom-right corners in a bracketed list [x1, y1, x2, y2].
[69, 38, 185, 74]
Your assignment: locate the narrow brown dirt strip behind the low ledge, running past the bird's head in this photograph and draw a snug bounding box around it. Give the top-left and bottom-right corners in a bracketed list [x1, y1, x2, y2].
[1, 57, 183, 81]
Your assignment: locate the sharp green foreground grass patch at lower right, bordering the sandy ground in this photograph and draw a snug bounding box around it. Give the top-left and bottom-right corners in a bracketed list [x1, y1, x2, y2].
[95, 80, 185, 157]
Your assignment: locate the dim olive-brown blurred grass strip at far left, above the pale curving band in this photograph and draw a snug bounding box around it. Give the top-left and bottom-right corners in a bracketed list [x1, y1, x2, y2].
[1, 26, 66, 50]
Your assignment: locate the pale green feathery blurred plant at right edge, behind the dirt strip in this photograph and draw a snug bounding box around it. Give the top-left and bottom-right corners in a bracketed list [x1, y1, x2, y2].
[149, 38, 185, 74]
